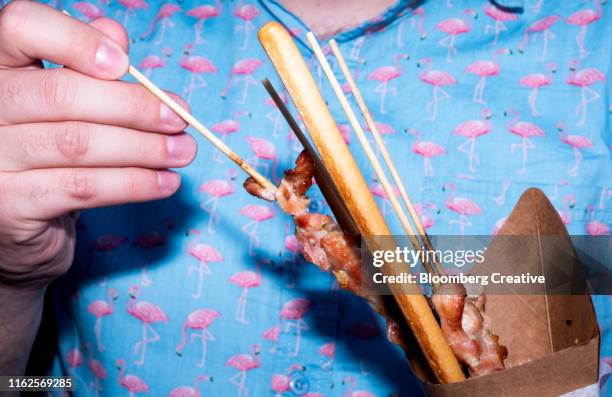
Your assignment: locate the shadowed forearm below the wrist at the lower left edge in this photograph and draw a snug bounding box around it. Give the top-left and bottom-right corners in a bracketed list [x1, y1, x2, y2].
[0, 284, 45, 375]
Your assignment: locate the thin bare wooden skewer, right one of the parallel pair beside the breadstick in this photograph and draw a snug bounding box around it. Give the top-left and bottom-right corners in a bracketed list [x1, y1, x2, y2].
[329, 39, 444, 275]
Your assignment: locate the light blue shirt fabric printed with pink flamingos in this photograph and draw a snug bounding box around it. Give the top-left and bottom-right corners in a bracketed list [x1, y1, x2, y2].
[27, 0, 612, 396]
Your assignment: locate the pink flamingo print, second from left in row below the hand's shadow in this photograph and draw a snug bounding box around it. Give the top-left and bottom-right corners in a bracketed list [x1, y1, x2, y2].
[125, 285, 168, 365]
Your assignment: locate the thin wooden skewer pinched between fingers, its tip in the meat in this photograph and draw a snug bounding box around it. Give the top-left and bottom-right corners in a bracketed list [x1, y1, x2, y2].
[62, 10, 276, 192]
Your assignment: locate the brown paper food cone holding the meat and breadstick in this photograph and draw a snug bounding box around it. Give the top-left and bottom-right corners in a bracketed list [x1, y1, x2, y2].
[417, 189, 599, 397]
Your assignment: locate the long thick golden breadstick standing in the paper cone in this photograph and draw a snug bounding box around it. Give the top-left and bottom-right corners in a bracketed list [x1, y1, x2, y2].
[258, 22, 465, 383]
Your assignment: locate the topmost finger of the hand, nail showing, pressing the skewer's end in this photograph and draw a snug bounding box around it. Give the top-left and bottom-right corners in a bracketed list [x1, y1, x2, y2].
[0, 0, 129, 80]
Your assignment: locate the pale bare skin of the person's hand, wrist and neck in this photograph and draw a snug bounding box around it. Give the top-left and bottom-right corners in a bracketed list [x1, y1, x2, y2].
[0, 0, 391, 384]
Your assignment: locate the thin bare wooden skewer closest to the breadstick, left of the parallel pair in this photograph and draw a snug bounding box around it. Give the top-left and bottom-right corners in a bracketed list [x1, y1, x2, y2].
[306, 32, 435, 274]
